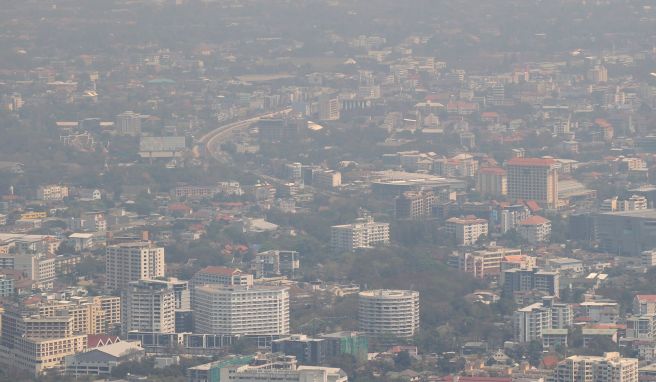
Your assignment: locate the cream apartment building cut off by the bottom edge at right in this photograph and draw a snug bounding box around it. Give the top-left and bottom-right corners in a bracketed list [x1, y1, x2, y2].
[551, 353, 638, 382]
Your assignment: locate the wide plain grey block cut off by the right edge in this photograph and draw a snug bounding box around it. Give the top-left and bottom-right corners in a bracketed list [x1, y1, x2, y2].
[594, 209, 656, 256]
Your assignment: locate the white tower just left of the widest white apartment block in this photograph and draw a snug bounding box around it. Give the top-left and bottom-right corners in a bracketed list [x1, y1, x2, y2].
[122, 280, 176, 334]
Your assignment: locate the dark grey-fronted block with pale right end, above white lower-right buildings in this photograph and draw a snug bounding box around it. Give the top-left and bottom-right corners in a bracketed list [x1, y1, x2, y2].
[503, 268, 560, 297]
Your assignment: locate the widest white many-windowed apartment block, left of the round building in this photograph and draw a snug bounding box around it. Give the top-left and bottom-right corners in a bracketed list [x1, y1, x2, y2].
[192, 285, 289, 335]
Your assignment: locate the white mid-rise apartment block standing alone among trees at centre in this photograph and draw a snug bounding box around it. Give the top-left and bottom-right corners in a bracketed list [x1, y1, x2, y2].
[330, 218, 390, 252]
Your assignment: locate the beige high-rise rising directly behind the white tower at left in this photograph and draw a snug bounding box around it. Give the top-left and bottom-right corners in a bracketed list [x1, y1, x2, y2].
[105, 242, 165, 289]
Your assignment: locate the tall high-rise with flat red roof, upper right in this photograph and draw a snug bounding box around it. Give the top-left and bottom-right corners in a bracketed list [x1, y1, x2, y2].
[506, 158, 558, 208]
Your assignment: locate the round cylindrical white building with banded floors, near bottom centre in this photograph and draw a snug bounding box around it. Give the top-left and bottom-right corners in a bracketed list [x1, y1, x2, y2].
[358, 289, 419, 338]
